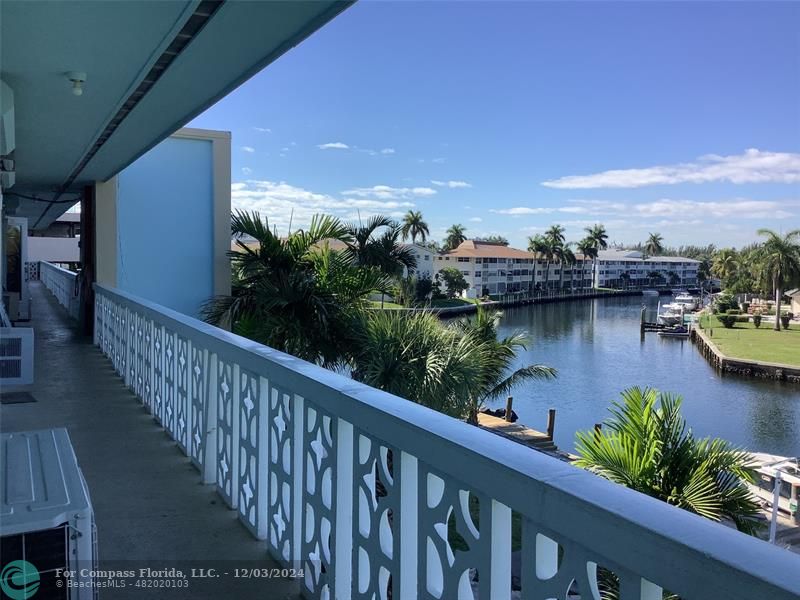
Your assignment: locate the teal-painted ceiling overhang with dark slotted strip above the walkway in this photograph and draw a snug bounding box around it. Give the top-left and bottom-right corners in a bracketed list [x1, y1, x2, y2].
[0, 0, 350, 227]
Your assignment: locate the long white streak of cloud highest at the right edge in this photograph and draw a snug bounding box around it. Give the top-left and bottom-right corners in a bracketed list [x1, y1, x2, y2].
[542, 148, 800, 189]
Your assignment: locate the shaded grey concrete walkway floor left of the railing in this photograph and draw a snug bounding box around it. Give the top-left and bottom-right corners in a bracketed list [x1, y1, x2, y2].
[0, 282, 300, 600]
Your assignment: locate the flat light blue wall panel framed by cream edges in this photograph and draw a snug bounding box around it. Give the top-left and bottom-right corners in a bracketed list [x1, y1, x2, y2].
[117, 138, 214, 316]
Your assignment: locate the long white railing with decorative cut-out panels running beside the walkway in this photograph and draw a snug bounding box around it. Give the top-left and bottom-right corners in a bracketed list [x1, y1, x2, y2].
[90, 285, 800, 600]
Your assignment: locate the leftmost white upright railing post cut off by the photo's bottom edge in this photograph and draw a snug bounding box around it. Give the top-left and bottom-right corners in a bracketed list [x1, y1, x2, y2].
[333, 419, 354, 600]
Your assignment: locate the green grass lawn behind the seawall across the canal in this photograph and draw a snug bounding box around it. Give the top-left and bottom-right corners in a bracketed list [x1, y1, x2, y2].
[700, 315, 800, 366]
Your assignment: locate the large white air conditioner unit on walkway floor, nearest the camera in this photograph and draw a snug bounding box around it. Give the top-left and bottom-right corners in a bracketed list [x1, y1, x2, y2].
[0, 429, 97, 600]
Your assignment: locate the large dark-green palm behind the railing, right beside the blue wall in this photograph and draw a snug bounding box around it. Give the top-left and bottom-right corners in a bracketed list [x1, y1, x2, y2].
[202, 211, 390, 366]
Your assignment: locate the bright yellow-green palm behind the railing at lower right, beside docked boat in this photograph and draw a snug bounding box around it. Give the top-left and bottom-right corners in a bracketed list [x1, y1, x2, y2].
[575, 387, 759, 534]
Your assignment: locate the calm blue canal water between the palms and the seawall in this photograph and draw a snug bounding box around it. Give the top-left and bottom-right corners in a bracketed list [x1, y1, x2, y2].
[493, 296, 800, 456]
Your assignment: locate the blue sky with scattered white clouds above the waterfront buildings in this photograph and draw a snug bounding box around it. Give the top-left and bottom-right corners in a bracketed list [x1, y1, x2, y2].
[191, 0, 800, 247]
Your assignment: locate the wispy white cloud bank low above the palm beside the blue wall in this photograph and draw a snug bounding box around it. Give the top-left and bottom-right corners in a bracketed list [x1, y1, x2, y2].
[231, 180, 415, 234]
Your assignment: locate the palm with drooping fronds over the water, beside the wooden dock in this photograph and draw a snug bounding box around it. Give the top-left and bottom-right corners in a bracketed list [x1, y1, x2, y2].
[453, 305, 556, 425]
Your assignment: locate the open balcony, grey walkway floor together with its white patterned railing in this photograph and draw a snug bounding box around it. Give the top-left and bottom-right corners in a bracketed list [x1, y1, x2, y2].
[14, 262, 800, 600]
